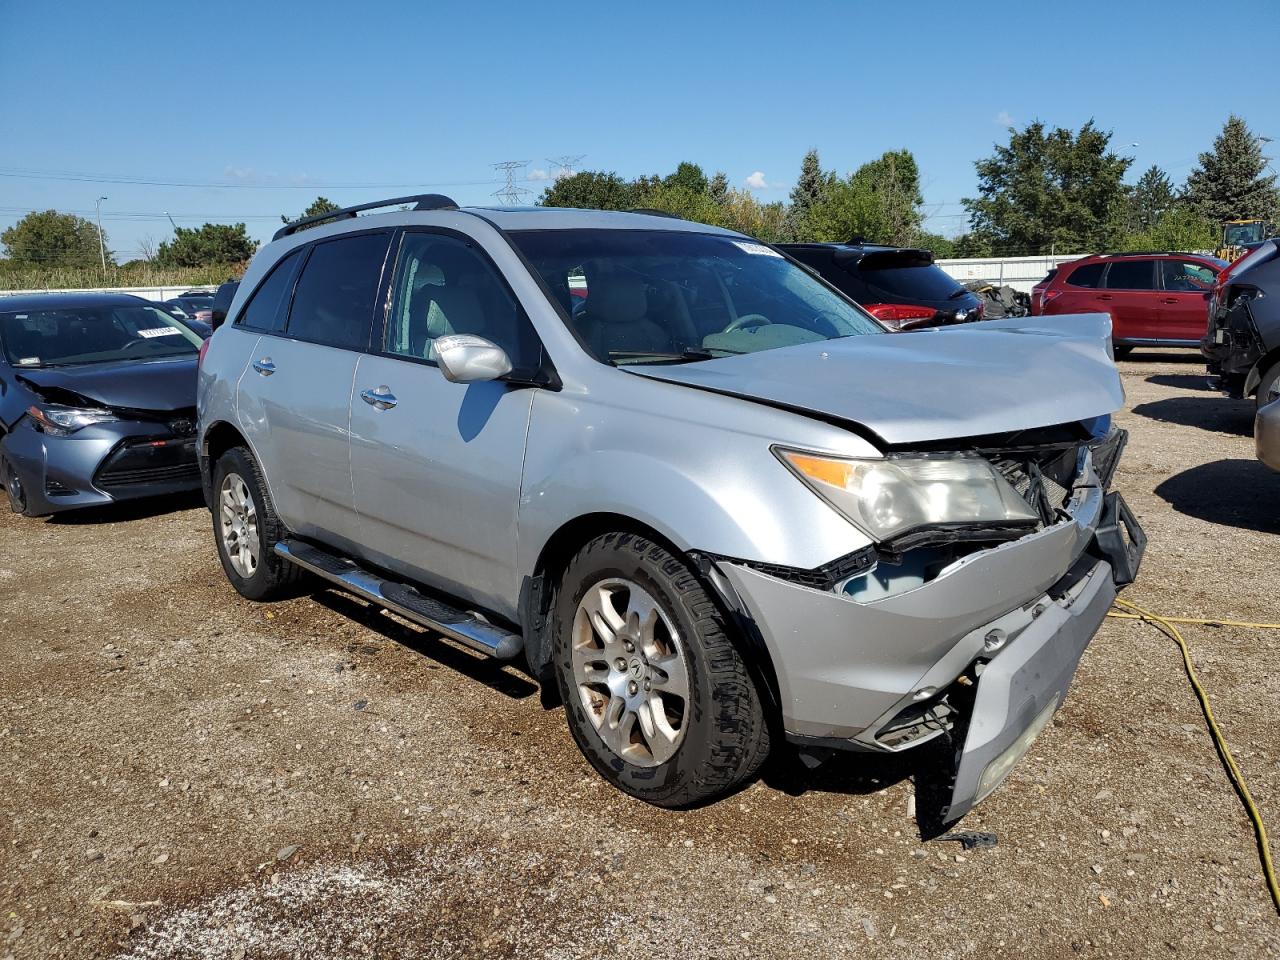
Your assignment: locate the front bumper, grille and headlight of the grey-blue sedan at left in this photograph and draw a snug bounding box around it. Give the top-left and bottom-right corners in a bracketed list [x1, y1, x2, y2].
[0, 378, 200, 516]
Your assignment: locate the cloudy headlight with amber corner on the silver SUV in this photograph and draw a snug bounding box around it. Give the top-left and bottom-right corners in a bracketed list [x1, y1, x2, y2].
[774, 447, 1039, 541]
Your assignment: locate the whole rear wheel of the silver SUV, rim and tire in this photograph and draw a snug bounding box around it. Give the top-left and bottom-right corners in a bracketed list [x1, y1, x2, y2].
[212, 447, 306, 600]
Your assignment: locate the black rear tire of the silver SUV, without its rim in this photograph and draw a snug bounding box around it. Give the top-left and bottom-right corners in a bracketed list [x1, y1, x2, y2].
[211, 447, 308, 600]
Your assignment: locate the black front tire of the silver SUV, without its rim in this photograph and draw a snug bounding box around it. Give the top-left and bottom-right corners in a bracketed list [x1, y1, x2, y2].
[550, 532, 771, 808]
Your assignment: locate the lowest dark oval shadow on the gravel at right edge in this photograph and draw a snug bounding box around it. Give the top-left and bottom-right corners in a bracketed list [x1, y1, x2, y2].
[1156, 460, 1280, 534]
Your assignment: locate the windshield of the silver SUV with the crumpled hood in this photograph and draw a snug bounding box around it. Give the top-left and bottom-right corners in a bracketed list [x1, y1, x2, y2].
[511, 230, 884, 364]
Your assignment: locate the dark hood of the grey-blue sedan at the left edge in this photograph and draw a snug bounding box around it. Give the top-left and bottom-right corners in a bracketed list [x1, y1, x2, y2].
[14, 356, 196, 411]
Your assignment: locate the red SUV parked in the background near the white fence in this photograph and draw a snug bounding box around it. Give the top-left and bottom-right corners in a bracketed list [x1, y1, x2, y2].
[1032, 253, 1226, 356]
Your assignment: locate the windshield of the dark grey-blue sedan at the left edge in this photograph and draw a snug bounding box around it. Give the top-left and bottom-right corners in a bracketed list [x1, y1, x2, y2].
[0, 303, 201, 366]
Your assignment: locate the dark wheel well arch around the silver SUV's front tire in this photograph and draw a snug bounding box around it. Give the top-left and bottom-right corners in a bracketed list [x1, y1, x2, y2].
[520, 513, 781, 721]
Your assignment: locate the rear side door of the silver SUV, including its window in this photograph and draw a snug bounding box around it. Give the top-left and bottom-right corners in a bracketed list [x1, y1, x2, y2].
[239, 230, 392, 550]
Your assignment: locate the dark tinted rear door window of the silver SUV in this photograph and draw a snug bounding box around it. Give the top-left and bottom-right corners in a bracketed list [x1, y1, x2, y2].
[287, 232, 390, 349]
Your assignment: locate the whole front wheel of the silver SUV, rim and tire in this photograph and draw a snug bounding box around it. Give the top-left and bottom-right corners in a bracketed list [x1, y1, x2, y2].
[552, 532, 769, 808]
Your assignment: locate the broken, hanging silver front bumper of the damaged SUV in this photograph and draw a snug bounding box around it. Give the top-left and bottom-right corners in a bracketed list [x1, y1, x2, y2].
[719, 486, 1146, 819]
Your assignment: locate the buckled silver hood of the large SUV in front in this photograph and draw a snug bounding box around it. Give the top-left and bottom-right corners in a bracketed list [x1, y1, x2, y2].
[627, 314, 1124, 445]
